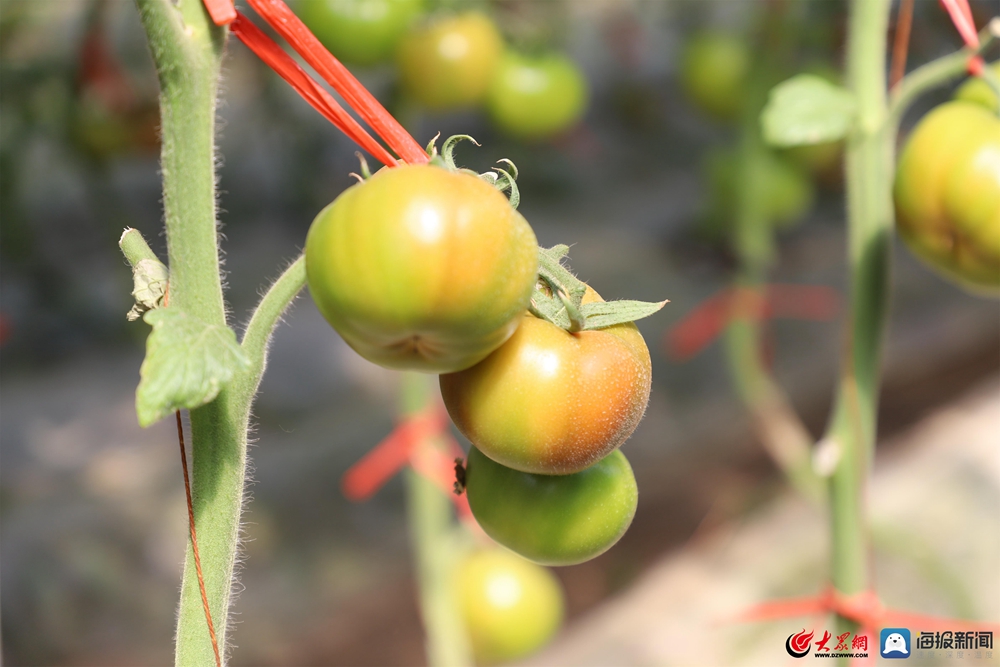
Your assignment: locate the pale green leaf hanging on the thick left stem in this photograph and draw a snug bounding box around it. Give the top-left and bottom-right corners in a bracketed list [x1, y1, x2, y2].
[135, 308, 250, 427]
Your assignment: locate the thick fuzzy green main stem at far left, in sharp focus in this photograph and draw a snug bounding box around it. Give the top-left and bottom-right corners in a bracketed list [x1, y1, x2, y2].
[136, 0, 236, 667]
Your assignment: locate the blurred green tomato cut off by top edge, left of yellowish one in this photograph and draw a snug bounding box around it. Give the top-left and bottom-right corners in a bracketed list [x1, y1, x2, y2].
[296, 0, 424, 65]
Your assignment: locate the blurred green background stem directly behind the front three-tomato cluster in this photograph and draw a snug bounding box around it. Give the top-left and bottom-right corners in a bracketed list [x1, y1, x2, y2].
[402, 373, 473, 667]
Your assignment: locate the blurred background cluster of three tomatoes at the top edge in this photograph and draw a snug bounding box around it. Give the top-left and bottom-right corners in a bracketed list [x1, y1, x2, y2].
[300, 0, 588, 140]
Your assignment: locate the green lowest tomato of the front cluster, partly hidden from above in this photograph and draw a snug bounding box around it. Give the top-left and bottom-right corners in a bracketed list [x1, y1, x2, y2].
[465, 447, 639, 565]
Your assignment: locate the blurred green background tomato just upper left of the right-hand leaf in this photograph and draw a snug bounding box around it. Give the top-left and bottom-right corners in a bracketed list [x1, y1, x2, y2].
[680, 32, 751, 121]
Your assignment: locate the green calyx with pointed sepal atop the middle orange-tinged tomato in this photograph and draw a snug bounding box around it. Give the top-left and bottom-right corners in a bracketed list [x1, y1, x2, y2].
[528, 244, 669, 333]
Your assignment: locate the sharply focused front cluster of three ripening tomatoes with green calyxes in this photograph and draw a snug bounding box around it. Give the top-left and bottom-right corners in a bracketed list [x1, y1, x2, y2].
[305, 145, 662, 565]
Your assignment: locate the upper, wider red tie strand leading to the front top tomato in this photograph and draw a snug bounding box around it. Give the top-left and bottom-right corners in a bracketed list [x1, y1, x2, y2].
[249, 0, 430, 164]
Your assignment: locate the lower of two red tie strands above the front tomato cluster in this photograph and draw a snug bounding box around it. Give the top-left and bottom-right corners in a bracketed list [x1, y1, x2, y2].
[230, 12, 398, 167]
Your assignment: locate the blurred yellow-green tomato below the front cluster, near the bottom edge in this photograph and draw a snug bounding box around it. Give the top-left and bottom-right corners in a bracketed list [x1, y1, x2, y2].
[455, 548, 564, 664]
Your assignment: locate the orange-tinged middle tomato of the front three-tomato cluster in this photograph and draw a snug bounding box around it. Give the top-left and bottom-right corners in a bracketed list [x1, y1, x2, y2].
[441, 288, 652, 475]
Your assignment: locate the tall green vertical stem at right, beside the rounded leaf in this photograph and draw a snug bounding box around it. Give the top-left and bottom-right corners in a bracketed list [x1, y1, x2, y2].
[828, 0, 894, 627]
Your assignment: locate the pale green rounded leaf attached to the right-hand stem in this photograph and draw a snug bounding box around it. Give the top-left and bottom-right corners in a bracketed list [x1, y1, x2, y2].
[760, 74, 857, 146]
